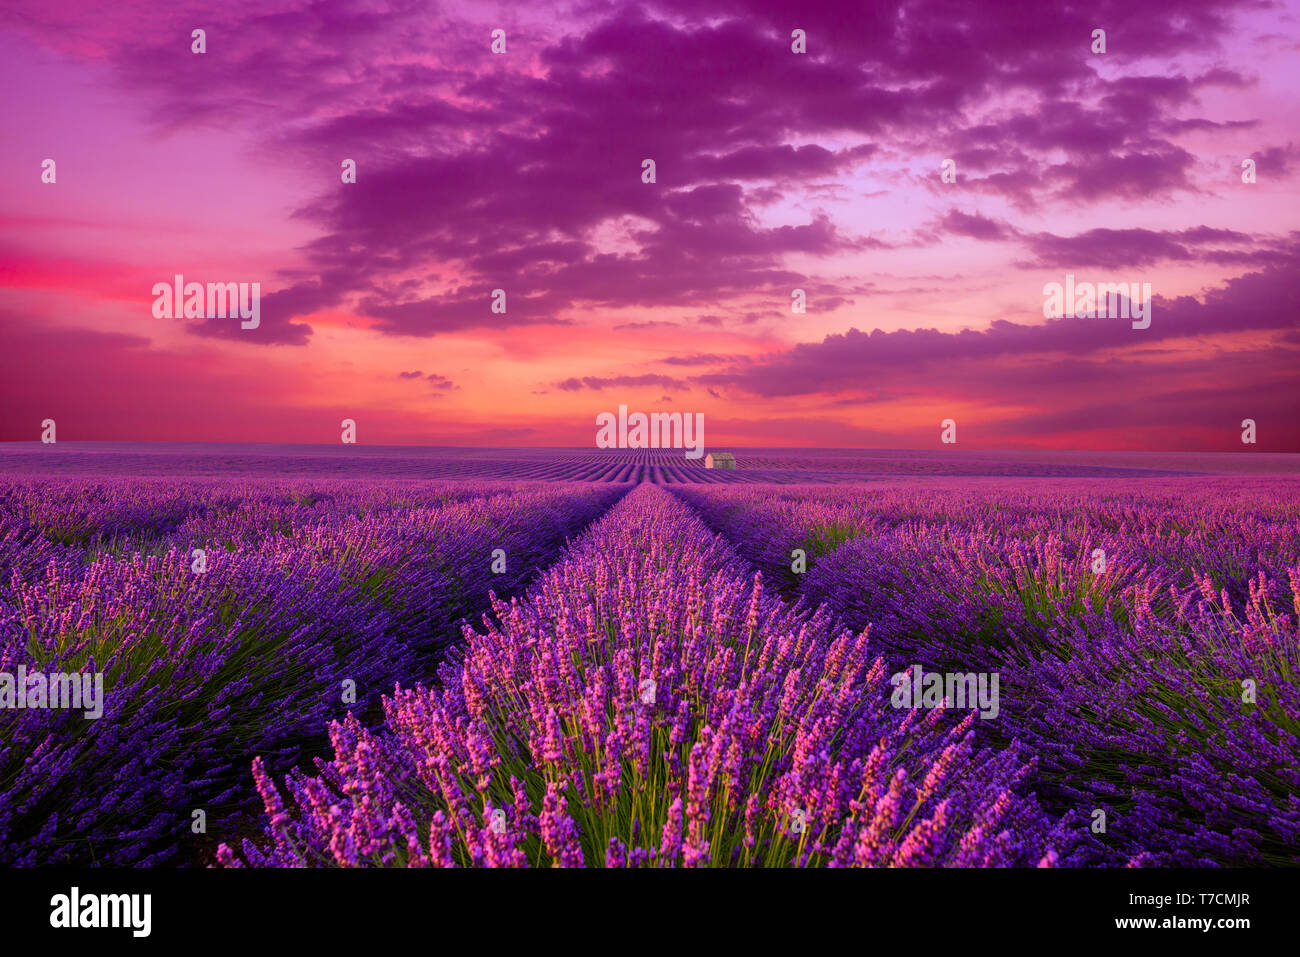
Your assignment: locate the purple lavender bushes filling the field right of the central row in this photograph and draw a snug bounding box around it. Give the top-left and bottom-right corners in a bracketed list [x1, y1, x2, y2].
[676, 479, 1300, 866]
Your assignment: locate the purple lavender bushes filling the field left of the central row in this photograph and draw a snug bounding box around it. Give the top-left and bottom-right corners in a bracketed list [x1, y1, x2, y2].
[0, 480, 627, 865]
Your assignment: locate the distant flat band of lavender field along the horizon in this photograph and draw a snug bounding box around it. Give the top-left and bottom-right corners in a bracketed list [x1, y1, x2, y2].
[0, 442, 1300, 485]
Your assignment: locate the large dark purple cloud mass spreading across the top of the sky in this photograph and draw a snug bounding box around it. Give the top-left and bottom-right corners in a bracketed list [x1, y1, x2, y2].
[7, 0, 1268, 345]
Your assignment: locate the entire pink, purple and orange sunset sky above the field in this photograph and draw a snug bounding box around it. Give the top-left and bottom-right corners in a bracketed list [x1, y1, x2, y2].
[0, 0, 1300, 451]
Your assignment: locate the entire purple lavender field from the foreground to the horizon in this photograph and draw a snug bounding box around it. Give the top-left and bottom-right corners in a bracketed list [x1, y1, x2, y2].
[0, 442, 1300, 867]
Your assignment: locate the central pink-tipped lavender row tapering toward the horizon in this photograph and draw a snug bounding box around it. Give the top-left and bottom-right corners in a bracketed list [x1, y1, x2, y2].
[218, 485, 1076, 867]
